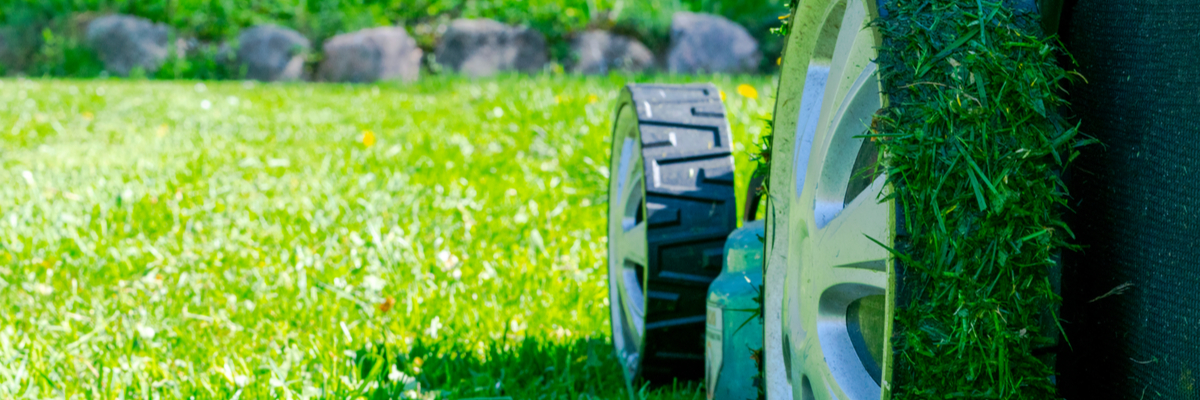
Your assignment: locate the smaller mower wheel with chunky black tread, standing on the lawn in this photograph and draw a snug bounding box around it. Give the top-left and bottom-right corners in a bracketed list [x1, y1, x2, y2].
[608, 85, 737, 389]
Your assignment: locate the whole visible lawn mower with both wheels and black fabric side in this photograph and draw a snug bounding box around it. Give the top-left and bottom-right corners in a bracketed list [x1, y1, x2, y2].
[608, 0, 1200, 399]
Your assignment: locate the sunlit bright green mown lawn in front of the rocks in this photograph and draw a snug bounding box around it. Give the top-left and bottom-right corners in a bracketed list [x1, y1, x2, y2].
[0, 76, 774, 399]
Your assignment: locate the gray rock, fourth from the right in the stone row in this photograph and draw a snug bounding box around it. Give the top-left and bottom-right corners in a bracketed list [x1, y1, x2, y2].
[319, 26, 421, 82]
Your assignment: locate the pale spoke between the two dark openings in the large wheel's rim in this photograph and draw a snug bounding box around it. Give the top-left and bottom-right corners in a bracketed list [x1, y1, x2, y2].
[815, 175, 892, 283]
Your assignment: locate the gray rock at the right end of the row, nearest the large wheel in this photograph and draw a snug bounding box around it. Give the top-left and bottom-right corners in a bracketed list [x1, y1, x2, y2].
[667, 12, 762, 73]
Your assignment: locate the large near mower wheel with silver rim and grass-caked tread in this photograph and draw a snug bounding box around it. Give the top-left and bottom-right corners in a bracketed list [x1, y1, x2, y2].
[764, 0, 1076, 399]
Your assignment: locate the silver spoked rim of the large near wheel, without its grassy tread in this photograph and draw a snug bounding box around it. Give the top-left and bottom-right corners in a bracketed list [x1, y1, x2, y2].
[766, 0, 895, 399]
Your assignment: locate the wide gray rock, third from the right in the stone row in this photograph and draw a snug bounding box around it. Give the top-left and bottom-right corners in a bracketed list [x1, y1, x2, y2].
[434, 19, 548, 77]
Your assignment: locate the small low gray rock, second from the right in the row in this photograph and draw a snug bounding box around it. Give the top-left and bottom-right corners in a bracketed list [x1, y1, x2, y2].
[571, 30, 654, 74]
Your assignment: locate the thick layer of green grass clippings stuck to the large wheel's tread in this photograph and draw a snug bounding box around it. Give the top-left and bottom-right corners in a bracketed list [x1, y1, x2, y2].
[868, 0, 1085, 399]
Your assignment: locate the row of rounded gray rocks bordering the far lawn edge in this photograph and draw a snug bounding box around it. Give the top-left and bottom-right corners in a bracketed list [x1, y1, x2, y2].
[0, 12, 761, 83]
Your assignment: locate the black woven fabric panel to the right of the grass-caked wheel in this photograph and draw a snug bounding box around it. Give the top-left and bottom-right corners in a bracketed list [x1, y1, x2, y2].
[1058, 0, 1200, 399]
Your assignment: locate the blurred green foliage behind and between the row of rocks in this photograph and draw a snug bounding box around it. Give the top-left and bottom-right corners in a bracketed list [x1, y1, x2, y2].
[0, 0, 787, 80]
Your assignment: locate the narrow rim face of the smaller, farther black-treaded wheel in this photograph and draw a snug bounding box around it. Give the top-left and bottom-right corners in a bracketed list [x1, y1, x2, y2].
[608, 99, 647, 382]
